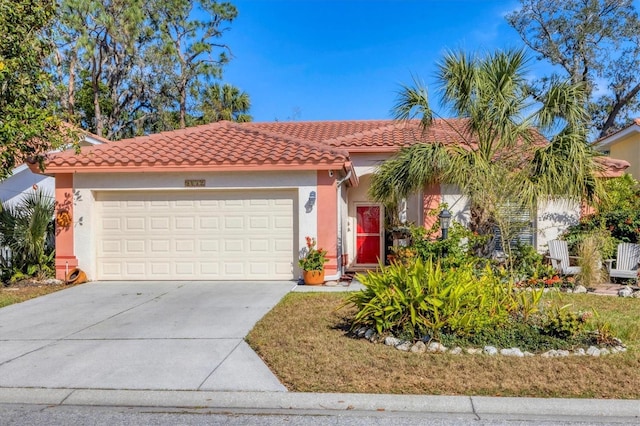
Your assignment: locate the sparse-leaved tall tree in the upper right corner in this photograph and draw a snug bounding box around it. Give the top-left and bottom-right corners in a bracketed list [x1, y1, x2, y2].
[507, 0, 640, 137]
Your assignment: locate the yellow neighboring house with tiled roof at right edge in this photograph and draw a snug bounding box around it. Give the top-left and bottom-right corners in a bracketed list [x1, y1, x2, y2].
[595, 118, 640, 180]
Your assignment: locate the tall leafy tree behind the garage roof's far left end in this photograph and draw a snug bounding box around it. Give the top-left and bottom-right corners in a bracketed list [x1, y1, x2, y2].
[53, 0, 150, 138]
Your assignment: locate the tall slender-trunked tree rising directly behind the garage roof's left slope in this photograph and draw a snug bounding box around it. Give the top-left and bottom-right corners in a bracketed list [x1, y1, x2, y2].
[150, 0, 238, 128]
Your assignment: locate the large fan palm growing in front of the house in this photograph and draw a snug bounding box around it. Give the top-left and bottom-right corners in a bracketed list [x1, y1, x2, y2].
[370, 50, 601, 264]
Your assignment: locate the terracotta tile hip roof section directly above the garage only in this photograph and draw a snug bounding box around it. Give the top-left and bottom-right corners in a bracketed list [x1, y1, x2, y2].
[46, 122, 349, 173]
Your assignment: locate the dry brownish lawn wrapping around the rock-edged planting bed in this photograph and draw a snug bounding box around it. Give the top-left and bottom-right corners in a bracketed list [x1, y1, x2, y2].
[247, 293, 640, 399]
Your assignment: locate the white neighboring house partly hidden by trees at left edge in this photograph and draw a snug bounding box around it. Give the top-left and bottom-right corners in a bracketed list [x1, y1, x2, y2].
[0, 133, 108, 205]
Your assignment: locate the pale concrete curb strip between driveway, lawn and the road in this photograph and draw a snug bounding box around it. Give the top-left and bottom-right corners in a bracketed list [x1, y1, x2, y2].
[0, 388, 640, 423]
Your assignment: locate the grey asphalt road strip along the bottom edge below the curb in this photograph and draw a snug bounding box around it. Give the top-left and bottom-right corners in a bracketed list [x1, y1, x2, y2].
[0, 404, 639, 426]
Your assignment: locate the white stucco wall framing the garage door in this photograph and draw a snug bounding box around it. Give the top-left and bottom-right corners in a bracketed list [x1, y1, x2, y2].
[74, 171, 318, 277]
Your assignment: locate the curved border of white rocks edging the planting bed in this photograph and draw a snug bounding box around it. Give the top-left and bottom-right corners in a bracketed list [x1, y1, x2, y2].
[354, 327, 627, 358]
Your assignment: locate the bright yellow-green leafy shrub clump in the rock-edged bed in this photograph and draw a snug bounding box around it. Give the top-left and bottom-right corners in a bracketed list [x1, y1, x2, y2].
[347, 258, 539, 339]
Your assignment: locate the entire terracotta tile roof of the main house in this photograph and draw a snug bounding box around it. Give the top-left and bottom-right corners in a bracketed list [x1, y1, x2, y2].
[41, 119, 621, 174]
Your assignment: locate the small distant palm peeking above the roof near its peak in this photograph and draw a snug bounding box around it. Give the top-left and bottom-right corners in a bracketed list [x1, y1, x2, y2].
[201, 83, 252, 123]
